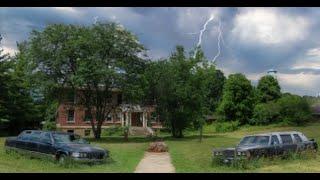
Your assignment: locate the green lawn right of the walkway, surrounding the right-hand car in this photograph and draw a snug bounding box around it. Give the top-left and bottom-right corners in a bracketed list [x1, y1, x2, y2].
[166, 123, 320, 172]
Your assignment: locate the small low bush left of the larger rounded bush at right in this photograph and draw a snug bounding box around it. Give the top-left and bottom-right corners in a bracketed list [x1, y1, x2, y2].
[249, 102, 280, 125]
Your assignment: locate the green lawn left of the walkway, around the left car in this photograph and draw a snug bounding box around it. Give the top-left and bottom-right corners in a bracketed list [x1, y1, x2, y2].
[0, 137, 148, 173]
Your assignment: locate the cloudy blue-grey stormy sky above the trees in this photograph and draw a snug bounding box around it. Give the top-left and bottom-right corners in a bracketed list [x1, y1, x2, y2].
[0, 7, 320, 96]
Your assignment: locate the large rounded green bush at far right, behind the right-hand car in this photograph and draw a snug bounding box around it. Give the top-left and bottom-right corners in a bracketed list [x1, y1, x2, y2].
[278, 94, 311, 125]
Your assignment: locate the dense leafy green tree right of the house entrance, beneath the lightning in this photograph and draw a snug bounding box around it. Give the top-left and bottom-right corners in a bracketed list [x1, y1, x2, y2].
[152, 46, 224, 137]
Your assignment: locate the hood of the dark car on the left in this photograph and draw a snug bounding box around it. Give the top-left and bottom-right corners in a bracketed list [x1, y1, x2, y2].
[59, 143, 106, 153]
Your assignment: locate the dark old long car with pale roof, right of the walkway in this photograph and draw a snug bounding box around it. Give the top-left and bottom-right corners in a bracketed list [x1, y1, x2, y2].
[213, 131, 318, 163]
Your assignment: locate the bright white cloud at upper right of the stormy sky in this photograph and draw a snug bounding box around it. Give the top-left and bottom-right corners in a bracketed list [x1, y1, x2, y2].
[232, 8, 310, 45]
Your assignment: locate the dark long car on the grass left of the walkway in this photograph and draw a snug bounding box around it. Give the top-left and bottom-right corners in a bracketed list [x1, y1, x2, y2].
[5, 130, 109, 163]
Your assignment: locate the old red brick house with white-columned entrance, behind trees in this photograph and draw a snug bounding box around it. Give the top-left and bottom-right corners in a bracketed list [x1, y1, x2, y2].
[56, 90, 160, 136]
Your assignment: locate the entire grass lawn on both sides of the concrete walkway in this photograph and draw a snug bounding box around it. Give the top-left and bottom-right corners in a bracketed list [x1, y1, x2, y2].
[0, 123, 320, 173]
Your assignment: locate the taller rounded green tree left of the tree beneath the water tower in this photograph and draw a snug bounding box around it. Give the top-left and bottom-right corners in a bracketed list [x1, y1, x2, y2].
[217, 73, 255, 124]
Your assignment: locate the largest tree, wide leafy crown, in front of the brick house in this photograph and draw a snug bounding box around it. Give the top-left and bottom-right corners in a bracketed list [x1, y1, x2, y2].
[21, 23, 145, 138]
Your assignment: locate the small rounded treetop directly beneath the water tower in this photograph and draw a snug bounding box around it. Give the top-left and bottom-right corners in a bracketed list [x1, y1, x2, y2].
[257, 75, 281, 103]
